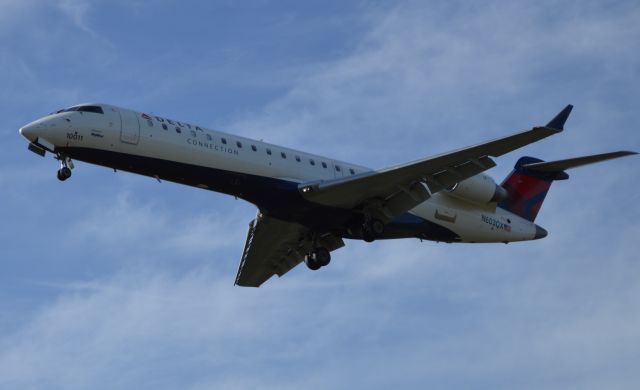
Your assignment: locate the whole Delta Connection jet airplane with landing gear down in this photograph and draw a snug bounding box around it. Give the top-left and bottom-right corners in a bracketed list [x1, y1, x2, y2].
[19, 103, 637, 287]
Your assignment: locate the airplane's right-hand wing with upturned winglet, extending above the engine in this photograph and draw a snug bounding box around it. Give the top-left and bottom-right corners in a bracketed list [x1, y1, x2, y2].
[299, 105, 573, 219]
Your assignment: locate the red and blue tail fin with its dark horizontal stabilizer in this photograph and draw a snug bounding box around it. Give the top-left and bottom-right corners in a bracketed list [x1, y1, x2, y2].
[498, 151, 636, 222]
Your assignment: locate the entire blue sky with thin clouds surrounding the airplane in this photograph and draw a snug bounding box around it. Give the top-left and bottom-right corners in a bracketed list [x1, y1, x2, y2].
[0, 0, 640, 389]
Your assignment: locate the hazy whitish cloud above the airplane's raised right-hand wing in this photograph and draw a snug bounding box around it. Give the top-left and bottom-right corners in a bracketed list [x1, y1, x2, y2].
[230, 2, 640, 167]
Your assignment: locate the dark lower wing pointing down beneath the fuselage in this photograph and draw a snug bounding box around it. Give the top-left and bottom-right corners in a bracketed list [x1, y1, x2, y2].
[235, 212, 344, 287]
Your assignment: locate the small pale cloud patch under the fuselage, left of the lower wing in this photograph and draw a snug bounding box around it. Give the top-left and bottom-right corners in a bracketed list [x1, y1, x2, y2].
[70, 192, 249, 257]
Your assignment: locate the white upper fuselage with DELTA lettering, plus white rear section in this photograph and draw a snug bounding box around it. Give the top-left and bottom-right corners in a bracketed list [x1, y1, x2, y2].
[21, 104, 536, 242]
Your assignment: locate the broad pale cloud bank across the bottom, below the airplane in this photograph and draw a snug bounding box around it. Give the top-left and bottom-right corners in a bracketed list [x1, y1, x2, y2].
[0, 235, 640, 388]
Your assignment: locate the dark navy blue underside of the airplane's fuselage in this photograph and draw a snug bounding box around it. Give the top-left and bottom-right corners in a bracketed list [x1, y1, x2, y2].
[58, 147, 458, 242]
